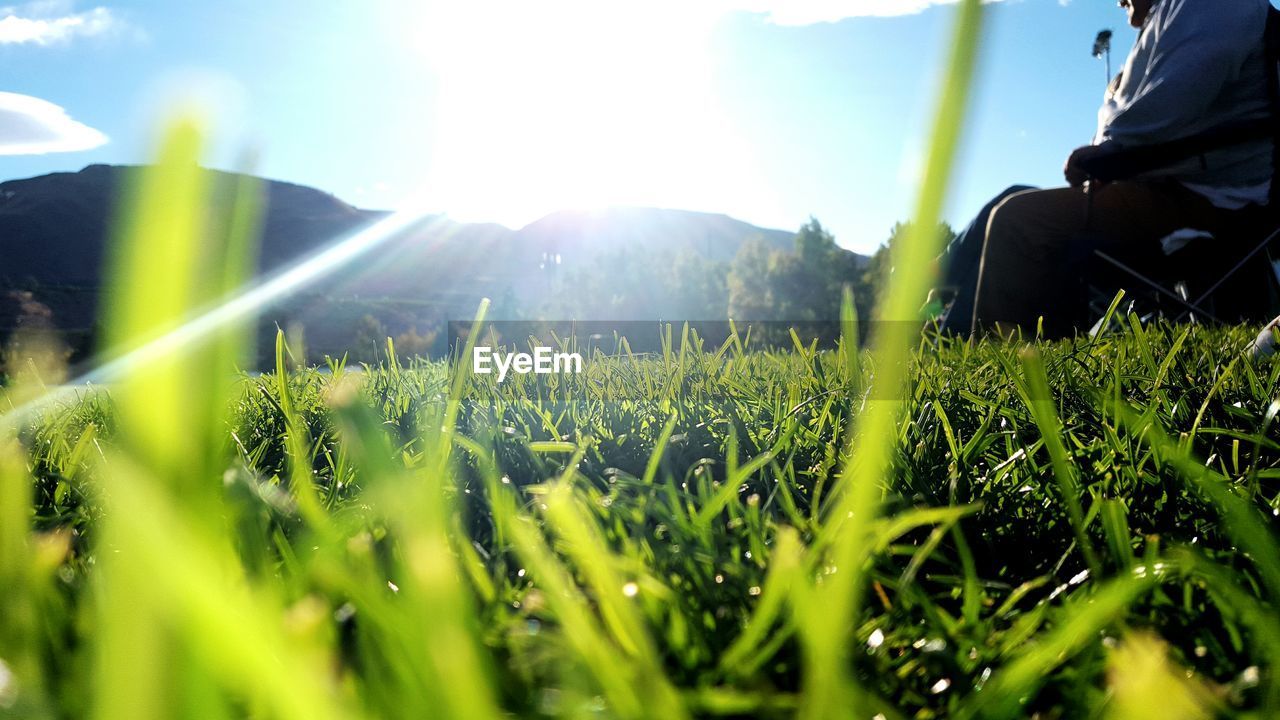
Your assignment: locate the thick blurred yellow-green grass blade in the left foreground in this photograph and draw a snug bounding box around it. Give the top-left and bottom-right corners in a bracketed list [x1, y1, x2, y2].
[93, 119, 340, 720]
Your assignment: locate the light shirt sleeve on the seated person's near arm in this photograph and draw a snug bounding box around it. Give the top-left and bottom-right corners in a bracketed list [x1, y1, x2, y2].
[1100, 0, 1265, 145]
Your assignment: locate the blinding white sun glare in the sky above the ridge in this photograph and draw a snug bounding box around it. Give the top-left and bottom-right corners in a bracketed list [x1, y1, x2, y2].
[407, 0, 769, 227]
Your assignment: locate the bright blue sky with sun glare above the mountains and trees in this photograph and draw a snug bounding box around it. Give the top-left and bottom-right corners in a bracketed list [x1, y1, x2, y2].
[0, 0, 1134, 252]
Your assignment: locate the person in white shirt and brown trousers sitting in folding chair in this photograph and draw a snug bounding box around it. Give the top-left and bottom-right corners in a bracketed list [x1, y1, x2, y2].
[942, 0, 1272, 337]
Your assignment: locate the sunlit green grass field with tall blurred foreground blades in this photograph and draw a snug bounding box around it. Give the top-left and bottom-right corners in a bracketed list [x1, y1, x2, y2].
[0, 0, 1280, 720]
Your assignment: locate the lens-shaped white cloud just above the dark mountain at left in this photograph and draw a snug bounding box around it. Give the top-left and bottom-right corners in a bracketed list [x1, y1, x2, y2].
[0, 92, 108, 155]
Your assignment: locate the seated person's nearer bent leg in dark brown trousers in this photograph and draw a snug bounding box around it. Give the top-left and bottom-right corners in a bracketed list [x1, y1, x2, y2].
[974, 182, 1222, 336]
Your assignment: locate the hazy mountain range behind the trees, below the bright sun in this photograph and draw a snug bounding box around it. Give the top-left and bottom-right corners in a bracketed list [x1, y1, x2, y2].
[0, 165, 865, 361]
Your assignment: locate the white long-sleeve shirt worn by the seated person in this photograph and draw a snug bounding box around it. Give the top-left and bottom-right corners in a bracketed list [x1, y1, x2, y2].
[1094, 0, 1274, 209]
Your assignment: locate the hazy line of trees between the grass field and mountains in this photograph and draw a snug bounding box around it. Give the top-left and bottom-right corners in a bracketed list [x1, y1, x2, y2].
[317, 218, 955, 360]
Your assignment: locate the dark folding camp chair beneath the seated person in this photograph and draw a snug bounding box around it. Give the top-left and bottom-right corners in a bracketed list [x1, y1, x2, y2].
[1084, 2, 1280, 323]
